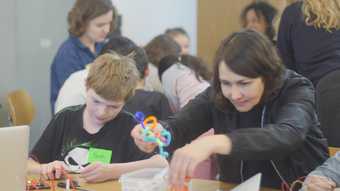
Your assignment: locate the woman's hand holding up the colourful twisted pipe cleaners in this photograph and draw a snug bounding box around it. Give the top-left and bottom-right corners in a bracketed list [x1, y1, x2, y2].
[131, 124, 157, 153]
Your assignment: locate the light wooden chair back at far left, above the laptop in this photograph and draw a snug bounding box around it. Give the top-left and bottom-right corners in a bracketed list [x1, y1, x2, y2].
[7, 90, 35, 125]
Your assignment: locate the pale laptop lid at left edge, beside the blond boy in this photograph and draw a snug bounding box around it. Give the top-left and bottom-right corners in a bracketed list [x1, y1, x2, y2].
[0, 126, 29, 191]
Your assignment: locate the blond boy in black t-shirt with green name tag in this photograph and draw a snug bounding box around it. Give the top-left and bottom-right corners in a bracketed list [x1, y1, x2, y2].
[28, 52, 167, 182]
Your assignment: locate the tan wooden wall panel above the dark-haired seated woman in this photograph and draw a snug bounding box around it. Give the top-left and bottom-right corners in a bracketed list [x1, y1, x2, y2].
[197, 0, 253, 64]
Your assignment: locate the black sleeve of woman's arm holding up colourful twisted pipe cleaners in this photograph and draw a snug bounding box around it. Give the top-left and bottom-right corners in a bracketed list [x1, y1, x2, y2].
[164, 88, 212, 152]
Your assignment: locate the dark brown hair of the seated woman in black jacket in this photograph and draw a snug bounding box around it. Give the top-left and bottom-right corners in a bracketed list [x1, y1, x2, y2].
[212, 30, 284, 108]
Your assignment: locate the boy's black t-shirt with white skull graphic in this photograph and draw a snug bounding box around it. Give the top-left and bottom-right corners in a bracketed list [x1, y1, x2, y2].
[31, 105, 151, 169]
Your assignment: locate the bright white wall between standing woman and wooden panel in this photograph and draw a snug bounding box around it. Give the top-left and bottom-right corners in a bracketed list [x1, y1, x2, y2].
[112, 0, 197, 54]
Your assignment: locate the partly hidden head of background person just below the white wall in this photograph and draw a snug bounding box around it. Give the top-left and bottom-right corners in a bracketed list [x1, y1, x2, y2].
[165, 27, 190, 54]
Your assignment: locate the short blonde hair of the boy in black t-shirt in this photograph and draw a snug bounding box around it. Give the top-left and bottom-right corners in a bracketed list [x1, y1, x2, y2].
[86, 52, 139, 101]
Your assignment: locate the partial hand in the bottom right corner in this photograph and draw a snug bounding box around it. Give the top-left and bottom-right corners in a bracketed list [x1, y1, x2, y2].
[303, 175, 336, 191]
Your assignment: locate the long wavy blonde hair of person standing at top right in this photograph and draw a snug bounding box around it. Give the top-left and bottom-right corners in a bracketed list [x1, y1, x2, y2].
[302, 0, 340, 31]
